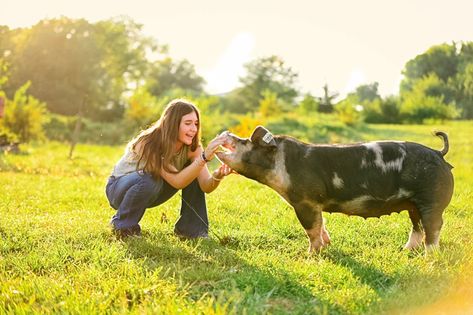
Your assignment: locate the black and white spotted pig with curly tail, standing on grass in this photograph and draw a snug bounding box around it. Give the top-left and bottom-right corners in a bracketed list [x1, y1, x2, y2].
[217, 126, 453, 251]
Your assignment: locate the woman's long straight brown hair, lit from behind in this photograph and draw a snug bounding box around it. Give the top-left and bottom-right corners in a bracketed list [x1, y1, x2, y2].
[128, 99, 200, 178]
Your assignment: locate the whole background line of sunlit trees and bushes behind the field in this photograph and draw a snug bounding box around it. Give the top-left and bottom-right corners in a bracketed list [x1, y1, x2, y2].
[0, 17, 473, 143]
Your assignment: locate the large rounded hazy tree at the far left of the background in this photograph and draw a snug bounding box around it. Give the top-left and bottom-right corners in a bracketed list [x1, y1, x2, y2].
[9, 18, 100, 115]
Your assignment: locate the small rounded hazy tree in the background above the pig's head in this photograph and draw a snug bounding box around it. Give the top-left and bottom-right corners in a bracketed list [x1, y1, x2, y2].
[238, 56, 298, 112]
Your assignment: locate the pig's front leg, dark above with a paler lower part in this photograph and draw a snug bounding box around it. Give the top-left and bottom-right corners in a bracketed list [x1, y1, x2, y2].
[294, 202, 330, 253]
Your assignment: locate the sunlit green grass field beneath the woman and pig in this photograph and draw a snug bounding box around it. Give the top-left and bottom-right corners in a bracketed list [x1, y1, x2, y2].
[0, 121, 473, 314]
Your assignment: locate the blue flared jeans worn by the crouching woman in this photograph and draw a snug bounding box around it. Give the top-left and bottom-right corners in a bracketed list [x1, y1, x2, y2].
[105, 171, 209, 238]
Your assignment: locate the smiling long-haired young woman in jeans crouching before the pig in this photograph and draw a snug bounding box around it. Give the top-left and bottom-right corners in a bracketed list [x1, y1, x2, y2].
[106, 99, 231, 238]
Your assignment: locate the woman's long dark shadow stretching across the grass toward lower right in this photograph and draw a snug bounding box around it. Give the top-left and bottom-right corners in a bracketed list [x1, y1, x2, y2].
[120, 233, 344, 314]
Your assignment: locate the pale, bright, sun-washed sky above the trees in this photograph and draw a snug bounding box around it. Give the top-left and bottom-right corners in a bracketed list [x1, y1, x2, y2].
[0, 0, 473, 96]
